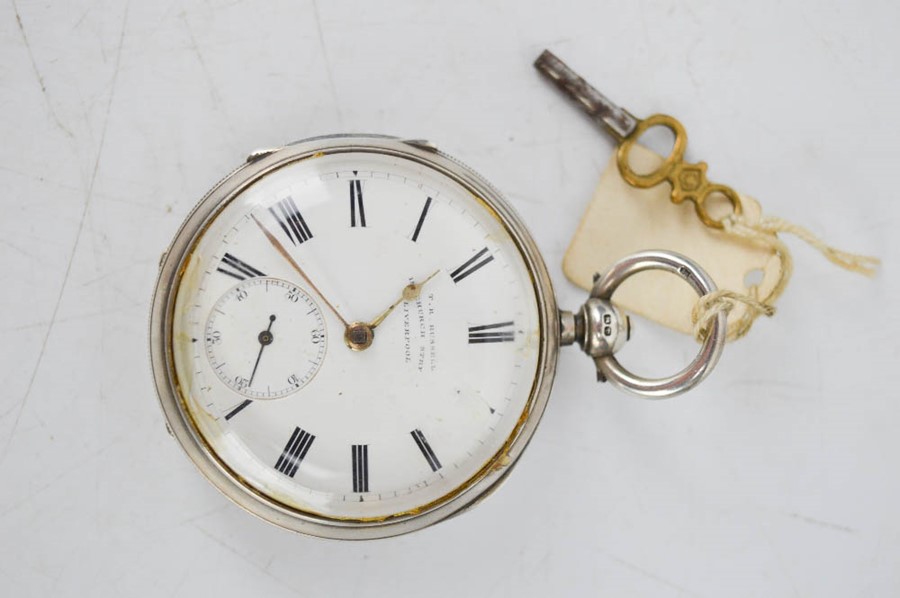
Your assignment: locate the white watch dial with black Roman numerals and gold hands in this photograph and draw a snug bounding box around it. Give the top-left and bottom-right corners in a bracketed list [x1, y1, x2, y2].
[172, 150, 542, 520]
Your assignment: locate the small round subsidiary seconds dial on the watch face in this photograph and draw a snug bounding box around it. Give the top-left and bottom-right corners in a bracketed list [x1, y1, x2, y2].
[204, 277, 326, 399]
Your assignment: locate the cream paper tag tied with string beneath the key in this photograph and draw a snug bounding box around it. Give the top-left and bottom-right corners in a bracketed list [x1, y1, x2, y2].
[563, 145, 780, 334]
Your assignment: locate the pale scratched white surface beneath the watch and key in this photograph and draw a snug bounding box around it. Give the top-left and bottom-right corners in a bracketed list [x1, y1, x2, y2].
[0, 0, 900, 597]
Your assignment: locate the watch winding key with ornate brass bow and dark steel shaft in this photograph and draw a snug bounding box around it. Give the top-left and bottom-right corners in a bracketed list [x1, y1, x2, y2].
[534, 50, 743, 229]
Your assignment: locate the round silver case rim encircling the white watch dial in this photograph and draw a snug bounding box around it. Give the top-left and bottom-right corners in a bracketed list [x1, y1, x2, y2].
[150, 135, 559, 540]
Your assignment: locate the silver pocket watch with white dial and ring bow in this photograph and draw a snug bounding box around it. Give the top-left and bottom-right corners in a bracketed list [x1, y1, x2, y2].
[150, 135, 725, 539]
